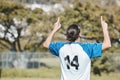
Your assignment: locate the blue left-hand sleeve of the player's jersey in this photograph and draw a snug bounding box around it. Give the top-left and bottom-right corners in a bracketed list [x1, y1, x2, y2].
[49, 42, 64, 56]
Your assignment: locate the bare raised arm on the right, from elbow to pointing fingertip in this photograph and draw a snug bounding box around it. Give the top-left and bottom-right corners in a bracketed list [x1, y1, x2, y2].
[101, 16, 111, 50]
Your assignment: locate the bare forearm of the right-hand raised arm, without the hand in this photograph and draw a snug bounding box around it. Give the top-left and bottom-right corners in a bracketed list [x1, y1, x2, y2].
[102, 29, 111, 50]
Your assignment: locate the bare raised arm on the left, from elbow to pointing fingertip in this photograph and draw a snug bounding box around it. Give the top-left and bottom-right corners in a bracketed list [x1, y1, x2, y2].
[43, 18, 61, 48]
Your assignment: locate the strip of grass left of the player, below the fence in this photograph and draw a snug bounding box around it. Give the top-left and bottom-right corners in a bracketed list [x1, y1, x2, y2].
[1, 67, 60, 78]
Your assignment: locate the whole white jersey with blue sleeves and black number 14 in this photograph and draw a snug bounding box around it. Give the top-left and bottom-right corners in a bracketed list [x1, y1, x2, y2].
[49, 42, 102, 80]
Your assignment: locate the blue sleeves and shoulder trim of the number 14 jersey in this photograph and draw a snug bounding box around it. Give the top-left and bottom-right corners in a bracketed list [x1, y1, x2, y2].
[49, 42, 102, 58]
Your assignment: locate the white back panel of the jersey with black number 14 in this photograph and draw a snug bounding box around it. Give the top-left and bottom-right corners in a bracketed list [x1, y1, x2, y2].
[59, 44, 91, 80]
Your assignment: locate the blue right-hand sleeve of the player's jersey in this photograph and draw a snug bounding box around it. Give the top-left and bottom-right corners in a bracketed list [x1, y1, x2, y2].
[80, 43, 102, 58]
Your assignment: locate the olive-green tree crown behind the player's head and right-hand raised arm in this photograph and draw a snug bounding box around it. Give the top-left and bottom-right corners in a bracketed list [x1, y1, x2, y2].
[61, 2, 120, 42]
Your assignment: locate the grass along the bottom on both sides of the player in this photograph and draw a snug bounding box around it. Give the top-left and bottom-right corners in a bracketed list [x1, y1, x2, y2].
[1, 67, 120, 80]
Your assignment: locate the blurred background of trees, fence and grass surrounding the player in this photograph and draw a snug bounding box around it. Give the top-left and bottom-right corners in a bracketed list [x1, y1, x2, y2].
[0, 0, 120, 80]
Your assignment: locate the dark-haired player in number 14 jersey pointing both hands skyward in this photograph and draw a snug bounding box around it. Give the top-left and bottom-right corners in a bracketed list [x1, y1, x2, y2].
[43, 16, 111, 80]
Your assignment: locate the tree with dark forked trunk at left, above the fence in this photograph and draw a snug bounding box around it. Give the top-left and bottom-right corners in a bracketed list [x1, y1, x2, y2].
[0, 1, 43, 51]
